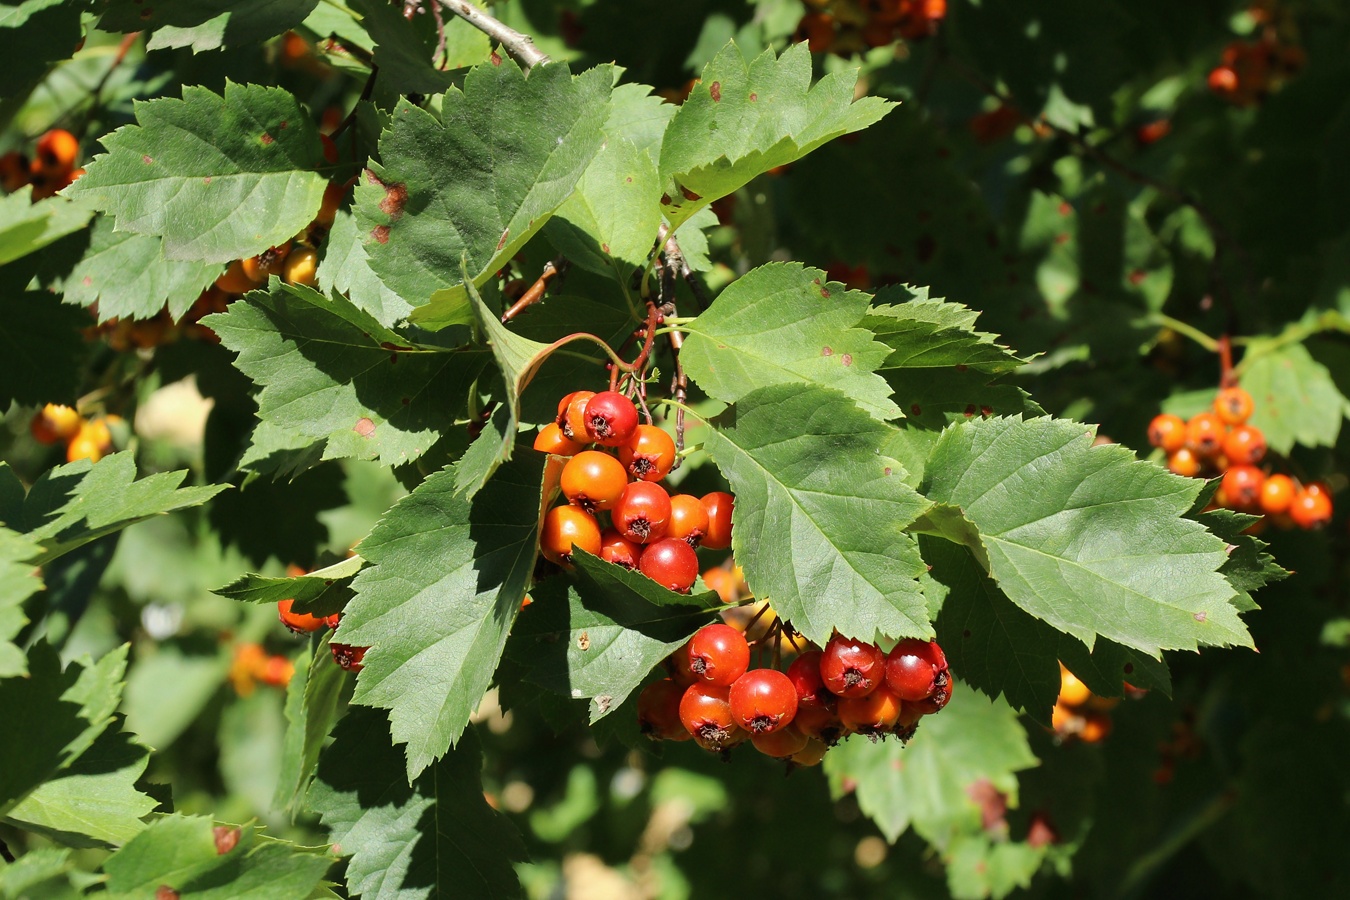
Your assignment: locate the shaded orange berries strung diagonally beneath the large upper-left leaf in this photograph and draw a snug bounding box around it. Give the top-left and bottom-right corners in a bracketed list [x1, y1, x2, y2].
[85, 135, 342, 352]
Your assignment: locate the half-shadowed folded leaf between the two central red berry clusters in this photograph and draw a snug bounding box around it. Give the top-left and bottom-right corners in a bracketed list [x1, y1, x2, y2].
[506, 552, 721, 723]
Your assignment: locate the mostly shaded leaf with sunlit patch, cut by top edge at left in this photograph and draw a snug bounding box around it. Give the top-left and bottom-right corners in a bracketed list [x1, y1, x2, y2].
[99, 0, 319, 53]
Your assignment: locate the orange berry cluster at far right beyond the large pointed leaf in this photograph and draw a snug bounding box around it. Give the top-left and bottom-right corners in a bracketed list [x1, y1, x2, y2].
[1149, 387, 1331, 530]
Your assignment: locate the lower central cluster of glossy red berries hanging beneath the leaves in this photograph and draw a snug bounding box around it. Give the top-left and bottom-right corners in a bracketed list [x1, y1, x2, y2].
[637, 623, 952, 766]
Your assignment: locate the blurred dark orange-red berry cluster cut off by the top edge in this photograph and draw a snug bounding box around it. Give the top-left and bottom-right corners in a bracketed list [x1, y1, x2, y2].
[794, 0, 946, 57]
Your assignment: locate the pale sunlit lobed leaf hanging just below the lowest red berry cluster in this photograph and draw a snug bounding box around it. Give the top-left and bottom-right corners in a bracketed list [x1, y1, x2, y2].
[824, 681, 1037, 849]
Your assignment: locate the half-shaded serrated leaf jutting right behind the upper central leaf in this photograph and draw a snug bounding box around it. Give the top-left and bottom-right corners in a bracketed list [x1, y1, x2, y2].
[863, 290, 1025, 374]
